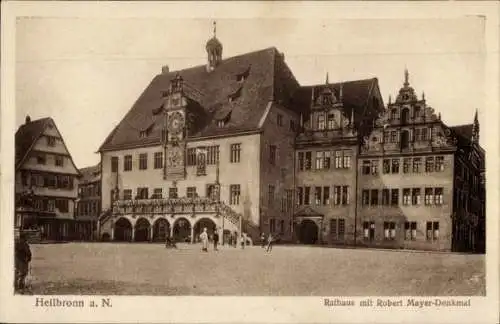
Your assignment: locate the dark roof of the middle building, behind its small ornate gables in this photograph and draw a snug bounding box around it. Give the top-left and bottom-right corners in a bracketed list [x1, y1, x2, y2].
[294, 78, 382, 128]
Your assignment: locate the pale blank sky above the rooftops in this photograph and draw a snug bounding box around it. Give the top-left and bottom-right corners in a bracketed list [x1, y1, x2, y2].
[15, 17, 486, 168]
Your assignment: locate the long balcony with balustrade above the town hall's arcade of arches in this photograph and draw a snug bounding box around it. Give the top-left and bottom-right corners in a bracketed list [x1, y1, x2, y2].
[113, 197, 218, 214]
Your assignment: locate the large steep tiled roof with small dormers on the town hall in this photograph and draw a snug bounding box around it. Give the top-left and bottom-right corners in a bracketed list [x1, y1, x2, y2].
[99, 47, 299, 151]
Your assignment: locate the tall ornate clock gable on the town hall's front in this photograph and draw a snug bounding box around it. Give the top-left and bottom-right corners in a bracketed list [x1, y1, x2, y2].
[164, 74, 187, 180]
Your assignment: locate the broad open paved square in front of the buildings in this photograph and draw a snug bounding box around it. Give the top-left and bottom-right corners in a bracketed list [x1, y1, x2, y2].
[23, 243, 485, 296]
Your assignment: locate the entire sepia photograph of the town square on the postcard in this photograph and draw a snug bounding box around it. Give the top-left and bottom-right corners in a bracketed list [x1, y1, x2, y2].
[2, 1, 498, 321]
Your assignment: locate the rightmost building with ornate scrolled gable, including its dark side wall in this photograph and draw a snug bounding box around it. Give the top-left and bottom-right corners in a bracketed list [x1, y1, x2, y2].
[357, 71, 484, 251]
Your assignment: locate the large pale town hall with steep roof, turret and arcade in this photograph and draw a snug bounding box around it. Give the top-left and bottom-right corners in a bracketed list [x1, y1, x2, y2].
[99, 29, 299, 241]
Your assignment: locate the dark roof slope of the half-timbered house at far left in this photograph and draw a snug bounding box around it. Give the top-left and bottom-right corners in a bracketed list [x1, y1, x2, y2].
[15, 117, 54, 168]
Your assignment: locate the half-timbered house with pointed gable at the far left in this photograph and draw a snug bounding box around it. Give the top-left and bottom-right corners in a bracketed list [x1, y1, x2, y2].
[15, 116, 79, 240]
